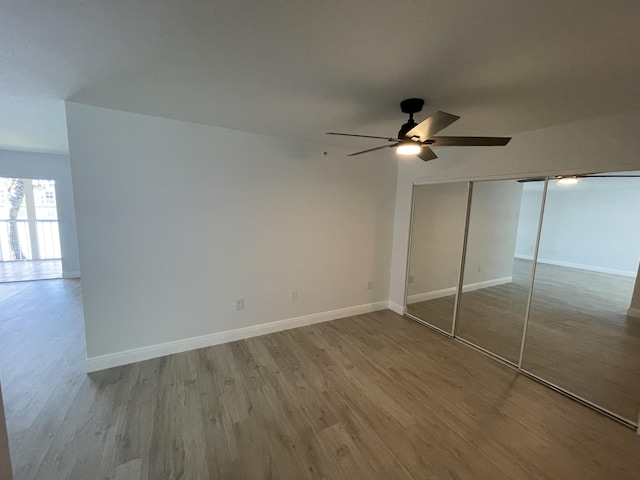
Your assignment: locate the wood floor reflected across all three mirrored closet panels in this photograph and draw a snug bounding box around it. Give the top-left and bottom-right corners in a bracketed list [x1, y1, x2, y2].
[407, 259, 640, 422]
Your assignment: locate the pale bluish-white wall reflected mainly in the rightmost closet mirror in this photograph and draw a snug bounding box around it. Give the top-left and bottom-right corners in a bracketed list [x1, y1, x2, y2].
[516, 178, 640, 277]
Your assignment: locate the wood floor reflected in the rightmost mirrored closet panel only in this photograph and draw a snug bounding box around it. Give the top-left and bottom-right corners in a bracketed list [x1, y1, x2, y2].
[522, 264, 640, 422]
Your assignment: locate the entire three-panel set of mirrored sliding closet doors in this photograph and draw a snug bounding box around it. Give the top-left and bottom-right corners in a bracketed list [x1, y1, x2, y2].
[406, 172, 640, 426]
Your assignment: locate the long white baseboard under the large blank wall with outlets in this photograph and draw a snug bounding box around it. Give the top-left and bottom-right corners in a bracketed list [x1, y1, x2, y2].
[86, 300, 389, 372]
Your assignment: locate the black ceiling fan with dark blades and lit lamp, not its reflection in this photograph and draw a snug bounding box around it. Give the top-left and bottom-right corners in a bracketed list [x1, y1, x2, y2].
[327, 98, 511, 162]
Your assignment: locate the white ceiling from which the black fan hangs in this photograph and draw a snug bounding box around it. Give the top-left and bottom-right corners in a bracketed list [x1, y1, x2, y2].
[0, 0, 640, 152]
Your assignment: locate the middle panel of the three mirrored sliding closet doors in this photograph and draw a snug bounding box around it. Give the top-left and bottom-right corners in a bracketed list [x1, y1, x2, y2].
[456, 180, 544, 364]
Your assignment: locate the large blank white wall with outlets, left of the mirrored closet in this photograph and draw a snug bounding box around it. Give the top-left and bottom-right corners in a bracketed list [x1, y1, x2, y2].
[67, 103, 397, 369]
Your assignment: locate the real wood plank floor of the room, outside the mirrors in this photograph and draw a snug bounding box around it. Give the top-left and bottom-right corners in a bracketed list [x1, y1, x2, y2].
[0, 280, 640, 480]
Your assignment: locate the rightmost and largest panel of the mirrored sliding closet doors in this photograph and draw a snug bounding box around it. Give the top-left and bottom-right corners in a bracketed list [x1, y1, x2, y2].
[522, 173, 640, 422]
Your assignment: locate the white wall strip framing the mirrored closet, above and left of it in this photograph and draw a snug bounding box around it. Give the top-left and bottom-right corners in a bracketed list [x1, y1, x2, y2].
[389, 109, 640, 305]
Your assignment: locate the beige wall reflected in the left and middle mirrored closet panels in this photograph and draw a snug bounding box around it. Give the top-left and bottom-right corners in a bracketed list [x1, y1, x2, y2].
[407, 181, 522, 303]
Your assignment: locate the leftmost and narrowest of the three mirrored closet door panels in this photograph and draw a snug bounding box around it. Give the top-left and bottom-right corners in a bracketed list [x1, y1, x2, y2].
[406, 183, 469, 334]
